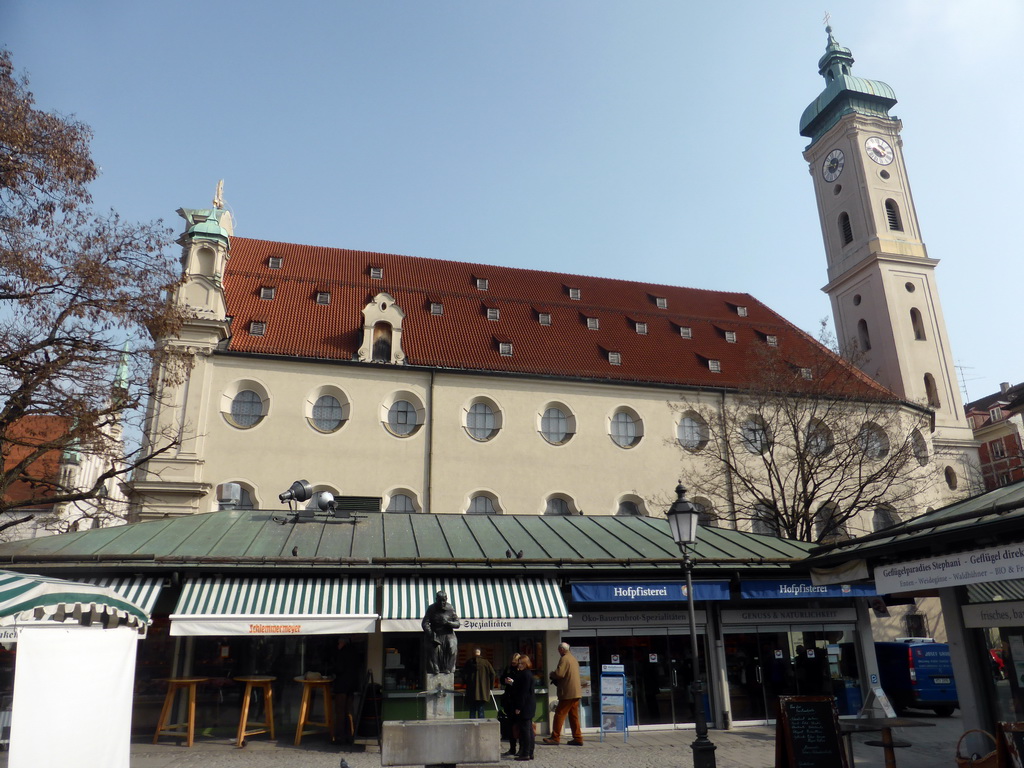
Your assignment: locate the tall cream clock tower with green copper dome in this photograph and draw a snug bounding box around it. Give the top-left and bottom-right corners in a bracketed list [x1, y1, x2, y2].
[800, 27, 977, 488]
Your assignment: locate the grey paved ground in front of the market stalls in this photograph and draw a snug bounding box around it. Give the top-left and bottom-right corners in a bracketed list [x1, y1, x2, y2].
[6, 713, 964, 768]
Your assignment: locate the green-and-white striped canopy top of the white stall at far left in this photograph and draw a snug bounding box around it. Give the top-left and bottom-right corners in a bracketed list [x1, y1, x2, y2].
[0, 570, 150, 628]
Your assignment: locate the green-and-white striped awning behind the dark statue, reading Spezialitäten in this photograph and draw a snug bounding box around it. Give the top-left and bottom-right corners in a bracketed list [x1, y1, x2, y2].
[381, 577, 569, 632]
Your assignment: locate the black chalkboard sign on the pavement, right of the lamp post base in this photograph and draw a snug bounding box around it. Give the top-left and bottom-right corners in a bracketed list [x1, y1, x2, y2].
[775, 696, 850, 768]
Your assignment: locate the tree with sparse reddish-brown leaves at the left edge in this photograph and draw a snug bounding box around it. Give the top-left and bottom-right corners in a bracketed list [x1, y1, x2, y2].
[0, 50, 190, 529]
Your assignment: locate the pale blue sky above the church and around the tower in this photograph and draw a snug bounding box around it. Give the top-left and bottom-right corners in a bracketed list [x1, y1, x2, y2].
[0, 0, 1024, 399]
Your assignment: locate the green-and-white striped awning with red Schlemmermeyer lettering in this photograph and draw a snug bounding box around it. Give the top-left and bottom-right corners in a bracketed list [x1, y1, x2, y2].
[171, 575, 377, 636]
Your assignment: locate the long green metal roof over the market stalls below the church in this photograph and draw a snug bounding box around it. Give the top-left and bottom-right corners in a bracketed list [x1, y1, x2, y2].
[0, 510, 813, 574]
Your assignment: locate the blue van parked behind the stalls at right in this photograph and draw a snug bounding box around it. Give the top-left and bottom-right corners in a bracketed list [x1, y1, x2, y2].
[874, 637, 959, 717]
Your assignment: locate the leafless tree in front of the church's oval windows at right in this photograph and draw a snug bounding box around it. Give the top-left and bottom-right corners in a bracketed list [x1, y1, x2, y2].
[673, 323, 936, 542]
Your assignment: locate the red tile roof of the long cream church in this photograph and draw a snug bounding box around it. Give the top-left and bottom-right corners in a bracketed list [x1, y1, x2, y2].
[224, 238, 891, 396]
